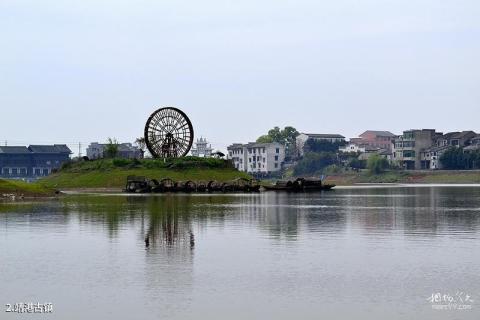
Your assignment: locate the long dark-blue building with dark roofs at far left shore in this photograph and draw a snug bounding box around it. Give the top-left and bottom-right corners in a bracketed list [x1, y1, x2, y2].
[0, 144, 72, 178]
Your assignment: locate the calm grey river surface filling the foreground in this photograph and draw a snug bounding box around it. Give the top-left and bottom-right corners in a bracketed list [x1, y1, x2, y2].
[0, 186, 480, 320]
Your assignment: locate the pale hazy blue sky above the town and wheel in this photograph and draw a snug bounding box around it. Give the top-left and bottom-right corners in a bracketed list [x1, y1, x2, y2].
[0, 0, 480, 154]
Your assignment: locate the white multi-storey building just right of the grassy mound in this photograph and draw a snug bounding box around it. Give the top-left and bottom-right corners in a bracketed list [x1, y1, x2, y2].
[227, 142, 285, 174]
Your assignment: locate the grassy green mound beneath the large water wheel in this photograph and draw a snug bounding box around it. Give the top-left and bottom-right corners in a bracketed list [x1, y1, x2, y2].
[39, 157, 250, 189]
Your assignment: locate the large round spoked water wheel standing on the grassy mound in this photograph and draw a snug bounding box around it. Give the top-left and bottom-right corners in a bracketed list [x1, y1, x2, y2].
[145, 108, 193, 158]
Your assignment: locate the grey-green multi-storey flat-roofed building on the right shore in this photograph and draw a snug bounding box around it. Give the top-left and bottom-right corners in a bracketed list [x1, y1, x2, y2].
[392, 129, 443, 170]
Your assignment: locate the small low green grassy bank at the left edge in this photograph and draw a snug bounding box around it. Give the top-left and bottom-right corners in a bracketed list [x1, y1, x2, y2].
[0, 179, 55, 200]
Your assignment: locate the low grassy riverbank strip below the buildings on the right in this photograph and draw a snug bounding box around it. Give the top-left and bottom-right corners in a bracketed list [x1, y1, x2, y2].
[325, 170, 480, 186]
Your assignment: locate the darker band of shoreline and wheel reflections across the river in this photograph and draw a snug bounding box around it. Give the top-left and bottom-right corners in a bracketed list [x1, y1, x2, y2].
[0, 187, 480, 241]
